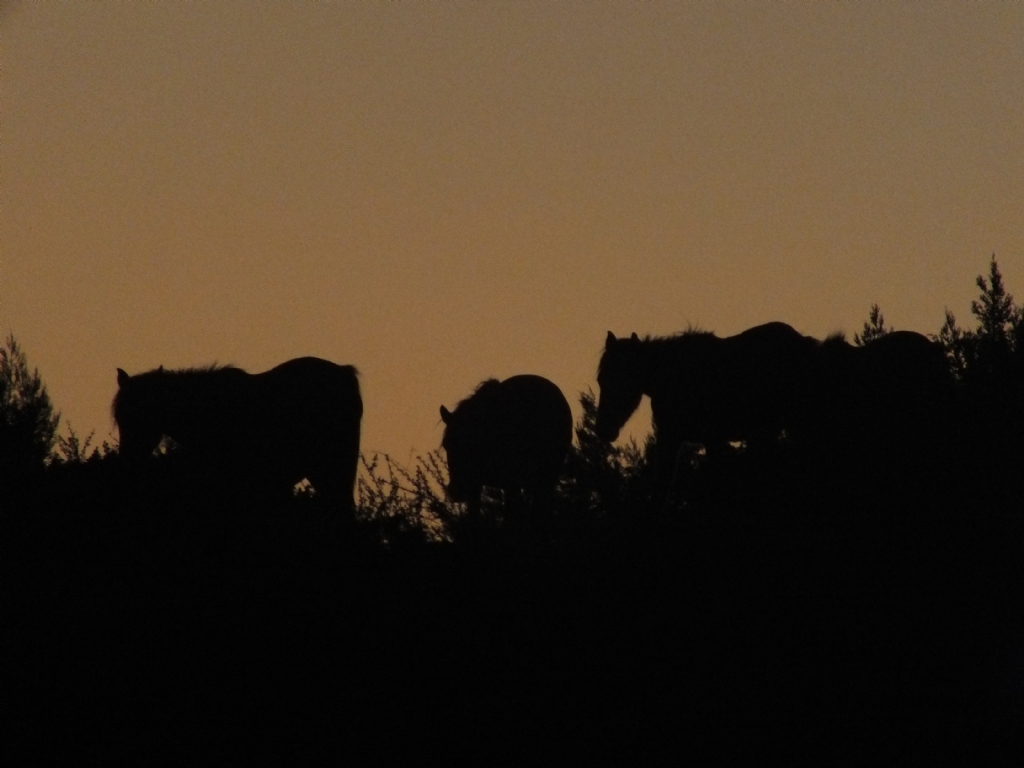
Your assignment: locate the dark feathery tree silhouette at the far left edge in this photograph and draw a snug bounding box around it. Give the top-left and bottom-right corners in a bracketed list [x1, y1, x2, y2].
[0, 335, 60, 479]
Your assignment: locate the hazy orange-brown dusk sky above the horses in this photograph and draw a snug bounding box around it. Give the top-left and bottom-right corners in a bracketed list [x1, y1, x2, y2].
[0, 0, 1024, 462]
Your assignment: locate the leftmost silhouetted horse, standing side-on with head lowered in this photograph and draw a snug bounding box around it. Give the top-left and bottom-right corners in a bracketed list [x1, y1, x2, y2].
[112, 357, 362, 510]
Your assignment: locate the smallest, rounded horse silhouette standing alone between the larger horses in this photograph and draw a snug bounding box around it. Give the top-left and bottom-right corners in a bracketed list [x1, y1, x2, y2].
[440, 375, 572, 514]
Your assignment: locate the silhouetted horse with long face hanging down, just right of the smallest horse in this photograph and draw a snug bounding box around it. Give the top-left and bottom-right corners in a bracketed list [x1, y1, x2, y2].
[596, 323, 817, 492]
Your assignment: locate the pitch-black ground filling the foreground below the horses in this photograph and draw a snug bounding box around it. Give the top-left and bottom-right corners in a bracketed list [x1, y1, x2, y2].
[3, 460, 1024, 765]
